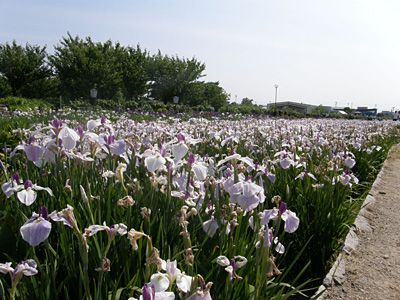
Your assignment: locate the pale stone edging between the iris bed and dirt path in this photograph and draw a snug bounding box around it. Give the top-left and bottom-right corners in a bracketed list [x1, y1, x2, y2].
[311, 163, 390, 300]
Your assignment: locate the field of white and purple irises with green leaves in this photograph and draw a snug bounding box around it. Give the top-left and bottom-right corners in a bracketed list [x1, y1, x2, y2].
[0, 110, 398, 300]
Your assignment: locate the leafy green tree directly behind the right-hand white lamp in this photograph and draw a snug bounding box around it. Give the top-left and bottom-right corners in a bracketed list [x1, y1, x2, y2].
[148, 52, 205, 104]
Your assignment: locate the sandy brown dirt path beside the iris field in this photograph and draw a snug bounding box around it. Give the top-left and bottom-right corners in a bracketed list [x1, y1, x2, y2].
[322, 145, 400, 300]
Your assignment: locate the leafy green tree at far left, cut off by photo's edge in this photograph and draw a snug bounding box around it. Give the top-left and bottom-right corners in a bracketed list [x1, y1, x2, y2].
[0, 41, 54, 98]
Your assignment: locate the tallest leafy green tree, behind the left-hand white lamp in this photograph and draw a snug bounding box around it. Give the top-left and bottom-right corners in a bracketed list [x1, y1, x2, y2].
[51, 33, 124, 99]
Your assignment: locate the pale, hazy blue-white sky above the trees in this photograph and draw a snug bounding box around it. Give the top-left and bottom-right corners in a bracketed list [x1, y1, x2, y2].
[0, 0, 400, 111]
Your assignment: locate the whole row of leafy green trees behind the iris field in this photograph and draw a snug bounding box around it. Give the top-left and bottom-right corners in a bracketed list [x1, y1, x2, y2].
[0, 33, 229, 109]
